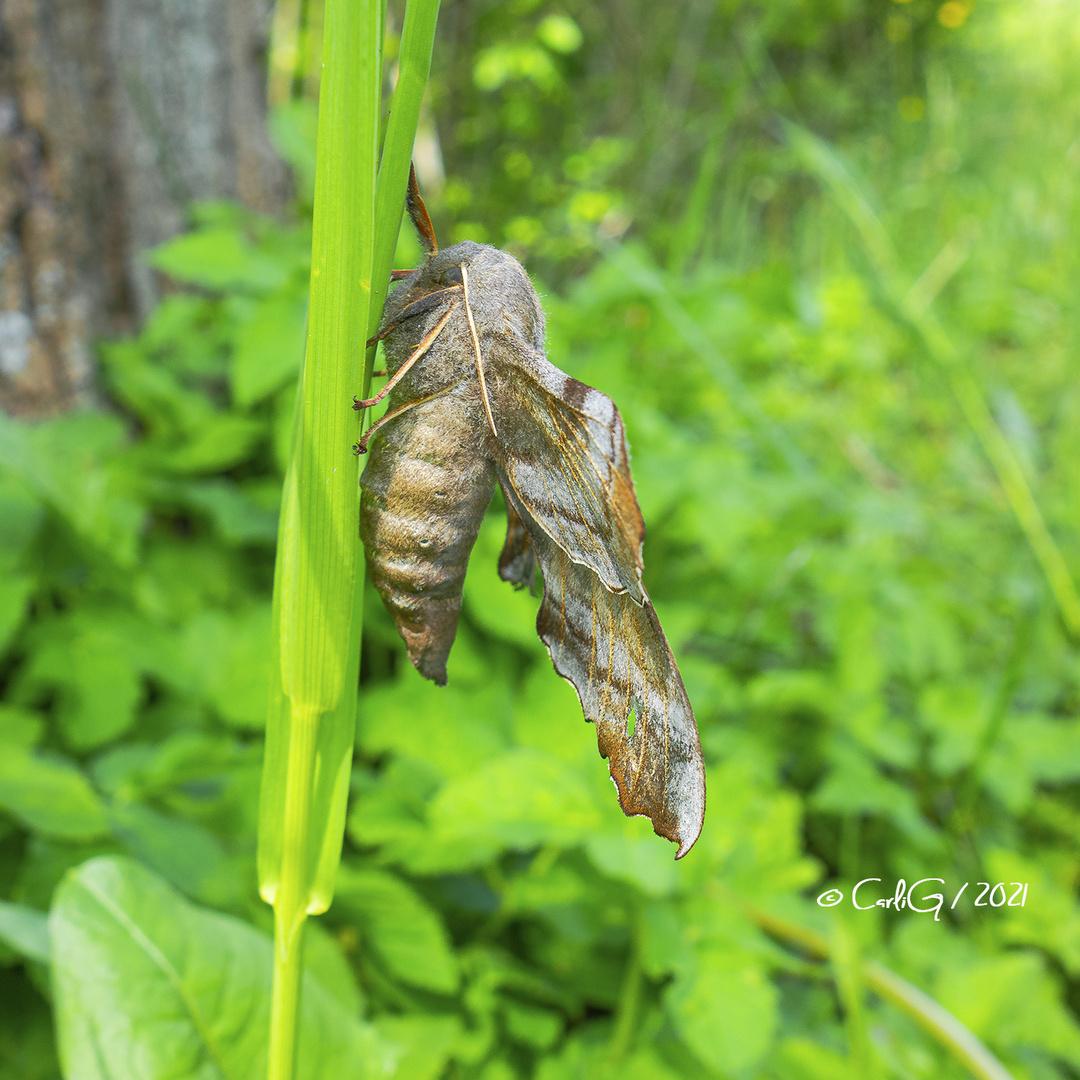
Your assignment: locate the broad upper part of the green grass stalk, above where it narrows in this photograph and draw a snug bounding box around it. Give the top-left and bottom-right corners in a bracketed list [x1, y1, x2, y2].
[279, 8, 379, 713]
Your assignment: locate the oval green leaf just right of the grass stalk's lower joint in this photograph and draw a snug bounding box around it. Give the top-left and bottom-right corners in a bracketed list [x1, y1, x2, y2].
[336, 866, 458, 994]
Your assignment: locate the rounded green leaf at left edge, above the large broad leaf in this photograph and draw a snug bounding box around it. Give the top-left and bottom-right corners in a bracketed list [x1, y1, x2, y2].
[0, 742, 108, 840]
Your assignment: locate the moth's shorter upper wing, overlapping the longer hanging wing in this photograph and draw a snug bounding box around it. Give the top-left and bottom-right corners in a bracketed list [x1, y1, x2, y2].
[484, 336, 645, 604]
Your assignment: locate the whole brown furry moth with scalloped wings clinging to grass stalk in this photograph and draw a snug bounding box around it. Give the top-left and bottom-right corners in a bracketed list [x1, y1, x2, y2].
[354, 176, 705, 859]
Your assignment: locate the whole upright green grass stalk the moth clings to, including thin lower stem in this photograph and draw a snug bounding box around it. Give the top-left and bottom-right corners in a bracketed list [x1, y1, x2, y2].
[259, 0, 382, 1080]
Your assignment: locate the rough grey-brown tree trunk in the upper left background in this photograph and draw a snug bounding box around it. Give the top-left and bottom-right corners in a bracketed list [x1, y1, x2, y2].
[0, 0, 287, 416]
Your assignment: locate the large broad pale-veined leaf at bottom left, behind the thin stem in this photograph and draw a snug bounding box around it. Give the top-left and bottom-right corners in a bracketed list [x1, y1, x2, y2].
[50, 858, 393, 1080]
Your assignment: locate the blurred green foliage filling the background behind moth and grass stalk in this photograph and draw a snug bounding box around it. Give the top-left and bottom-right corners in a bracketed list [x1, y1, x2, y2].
[0, 0, 1080, 1080]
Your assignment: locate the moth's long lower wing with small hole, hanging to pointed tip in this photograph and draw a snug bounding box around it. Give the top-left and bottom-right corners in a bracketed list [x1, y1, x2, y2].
[503, 481, 705, 859]
